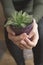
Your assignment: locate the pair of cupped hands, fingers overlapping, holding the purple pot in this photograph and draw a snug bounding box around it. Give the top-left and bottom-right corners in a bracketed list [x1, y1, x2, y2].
[7, 20, 39, 49]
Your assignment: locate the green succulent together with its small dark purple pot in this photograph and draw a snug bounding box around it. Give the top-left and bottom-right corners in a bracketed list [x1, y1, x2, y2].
[4, 11, 33, 35]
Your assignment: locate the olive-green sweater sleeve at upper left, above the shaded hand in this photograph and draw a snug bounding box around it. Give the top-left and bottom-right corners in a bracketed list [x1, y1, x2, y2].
[2, 0, 15, 17]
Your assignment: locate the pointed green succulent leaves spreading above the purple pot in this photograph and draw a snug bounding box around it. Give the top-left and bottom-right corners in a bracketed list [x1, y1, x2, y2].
[4, 11, 33, 28]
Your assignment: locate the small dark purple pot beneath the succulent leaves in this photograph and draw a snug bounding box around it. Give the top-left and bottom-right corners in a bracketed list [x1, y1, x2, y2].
[10, 23, 33, 35]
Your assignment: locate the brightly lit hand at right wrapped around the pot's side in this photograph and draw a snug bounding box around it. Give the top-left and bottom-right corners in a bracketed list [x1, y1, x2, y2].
[21, 19, 39, 49]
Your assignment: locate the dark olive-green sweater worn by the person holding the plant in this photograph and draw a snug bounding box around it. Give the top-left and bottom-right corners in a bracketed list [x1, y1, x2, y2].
[2, 0, 43, 22]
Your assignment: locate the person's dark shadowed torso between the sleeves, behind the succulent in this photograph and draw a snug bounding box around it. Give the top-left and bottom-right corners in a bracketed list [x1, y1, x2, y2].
[13, 0, 33, 12]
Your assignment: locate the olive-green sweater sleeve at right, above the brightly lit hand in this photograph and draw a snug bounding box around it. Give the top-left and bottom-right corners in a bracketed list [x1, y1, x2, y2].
[33, 0, 43, 22]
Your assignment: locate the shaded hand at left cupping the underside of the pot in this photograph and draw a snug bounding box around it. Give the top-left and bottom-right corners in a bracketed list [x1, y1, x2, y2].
[6, 26, 28, 49]
